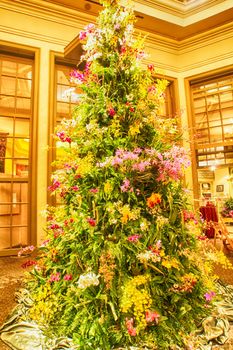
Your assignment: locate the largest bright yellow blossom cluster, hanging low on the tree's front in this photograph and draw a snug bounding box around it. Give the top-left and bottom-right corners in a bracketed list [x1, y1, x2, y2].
[121, 275, 152, 333]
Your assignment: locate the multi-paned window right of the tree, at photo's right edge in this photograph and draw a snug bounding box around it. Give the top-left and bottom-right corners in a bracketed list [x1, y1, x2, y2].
[191, 75, 233, 168]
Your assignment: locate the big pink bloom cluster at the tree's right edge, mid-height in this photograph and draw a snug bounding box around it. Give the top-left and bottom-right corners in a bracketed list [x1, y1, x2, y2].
[157, 146, 190, 181]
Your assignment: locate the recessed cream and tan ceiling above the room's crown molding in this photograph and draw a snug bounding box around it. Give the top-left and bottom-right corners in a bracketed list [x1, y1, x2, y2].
[44, 0, 233, 41]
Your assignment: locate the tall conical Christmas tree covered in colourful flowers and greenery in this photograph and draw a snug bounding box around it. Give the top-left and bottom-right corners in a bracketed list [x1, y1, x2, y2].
[28, 0, 218, 350]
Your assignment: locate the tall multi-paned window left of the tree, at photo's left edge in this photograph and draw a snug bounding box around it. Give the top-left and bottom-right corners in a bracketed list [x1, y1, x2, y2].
[0, 54, 34, 250]
